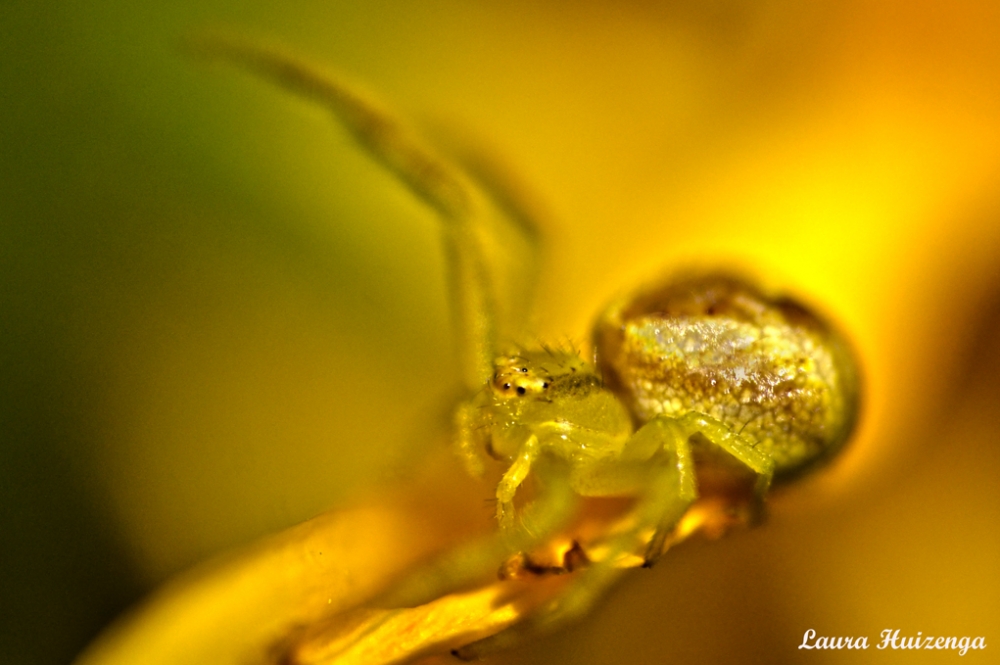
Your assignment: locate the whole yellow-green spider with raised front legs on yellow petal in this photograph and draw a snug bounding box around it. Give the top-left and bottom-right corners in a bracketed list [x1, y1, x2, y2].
[196, 36, 858, 657]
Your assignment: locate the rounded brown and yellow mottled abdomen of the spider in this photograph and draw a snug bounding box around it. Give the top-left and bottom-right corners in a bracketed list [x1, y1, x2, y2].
[596, 275, 857, 477]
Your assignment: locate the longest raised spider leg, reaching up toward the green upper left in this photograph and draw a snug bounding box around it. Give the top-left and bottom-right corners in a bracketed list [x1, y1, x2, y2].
[189, 35, 496, 390]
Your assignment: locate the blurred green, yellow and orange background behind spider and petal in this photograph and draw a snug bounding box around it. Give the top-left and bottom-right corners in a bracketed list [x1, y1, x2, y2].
[0, 0, 1000, 665]
